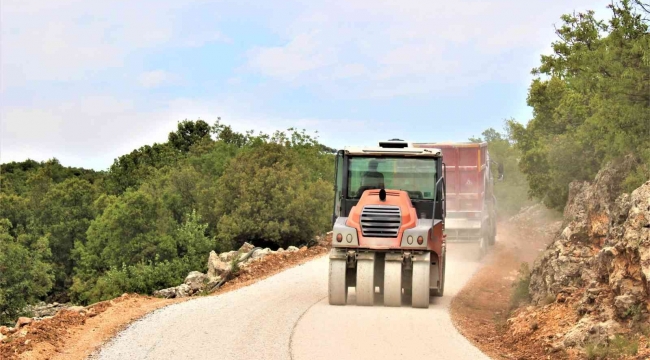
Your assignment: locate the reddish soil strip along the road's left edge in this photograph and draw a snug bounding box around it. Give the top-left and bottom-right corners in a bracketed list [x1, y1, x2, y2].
[0, 245, 329, 360]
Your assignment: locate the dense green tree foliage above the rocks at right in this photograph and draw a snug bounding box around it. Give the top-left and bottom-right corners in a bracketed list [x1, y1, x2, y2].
[509, 0, 650, 208]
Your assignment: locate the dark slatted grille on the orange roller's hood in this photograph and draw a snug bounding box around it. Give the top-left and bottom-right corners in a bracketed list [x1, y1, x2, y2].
[361, 205, 402, 238]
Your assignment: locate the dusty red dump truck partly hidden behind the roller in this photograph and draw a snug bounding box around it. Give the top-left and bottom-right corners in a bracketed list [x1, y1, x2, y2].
[413, 142, 503, 257]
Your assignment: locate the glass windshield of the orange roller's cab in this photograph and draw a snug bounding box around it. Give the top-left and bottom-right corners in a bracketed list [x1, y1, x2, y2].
[347, 157, 437, 200]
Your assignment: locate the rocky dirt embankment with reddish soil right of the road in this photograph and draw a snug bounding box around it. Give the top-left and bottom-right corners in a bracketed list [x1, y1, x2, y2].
[451, 169, 650, 359]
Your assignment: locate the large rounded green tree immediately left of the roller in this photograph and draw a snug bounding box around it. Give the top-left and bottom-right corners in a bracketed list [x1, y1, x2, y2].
[215, 143, 332, 248]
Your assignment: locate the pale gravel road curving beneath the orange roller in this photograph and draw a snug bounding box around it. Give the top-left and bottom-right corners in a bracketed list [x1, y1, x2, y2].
[91, 247, 488, 360]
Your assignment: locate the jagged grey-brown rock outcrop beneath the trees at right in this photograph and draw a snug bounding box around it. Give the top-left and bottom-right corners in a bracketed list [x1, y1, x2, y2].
[529, 157, 650, 346]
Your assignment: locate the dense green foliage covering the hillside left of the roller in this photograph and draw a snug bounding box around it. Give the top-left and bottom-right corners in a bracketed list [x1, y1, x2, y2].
[0, 120, 334, 322]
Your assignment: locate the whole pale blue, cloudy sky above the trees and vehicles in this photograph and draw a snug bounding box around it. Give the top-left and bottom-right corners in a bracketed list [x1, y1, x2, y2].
[0, 0, 608, 170]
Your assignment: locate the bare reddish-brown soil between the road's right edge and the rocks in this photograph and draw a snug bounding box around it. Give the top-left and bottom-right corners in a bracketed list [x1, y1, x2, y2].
[451, 219, 650, 360]
